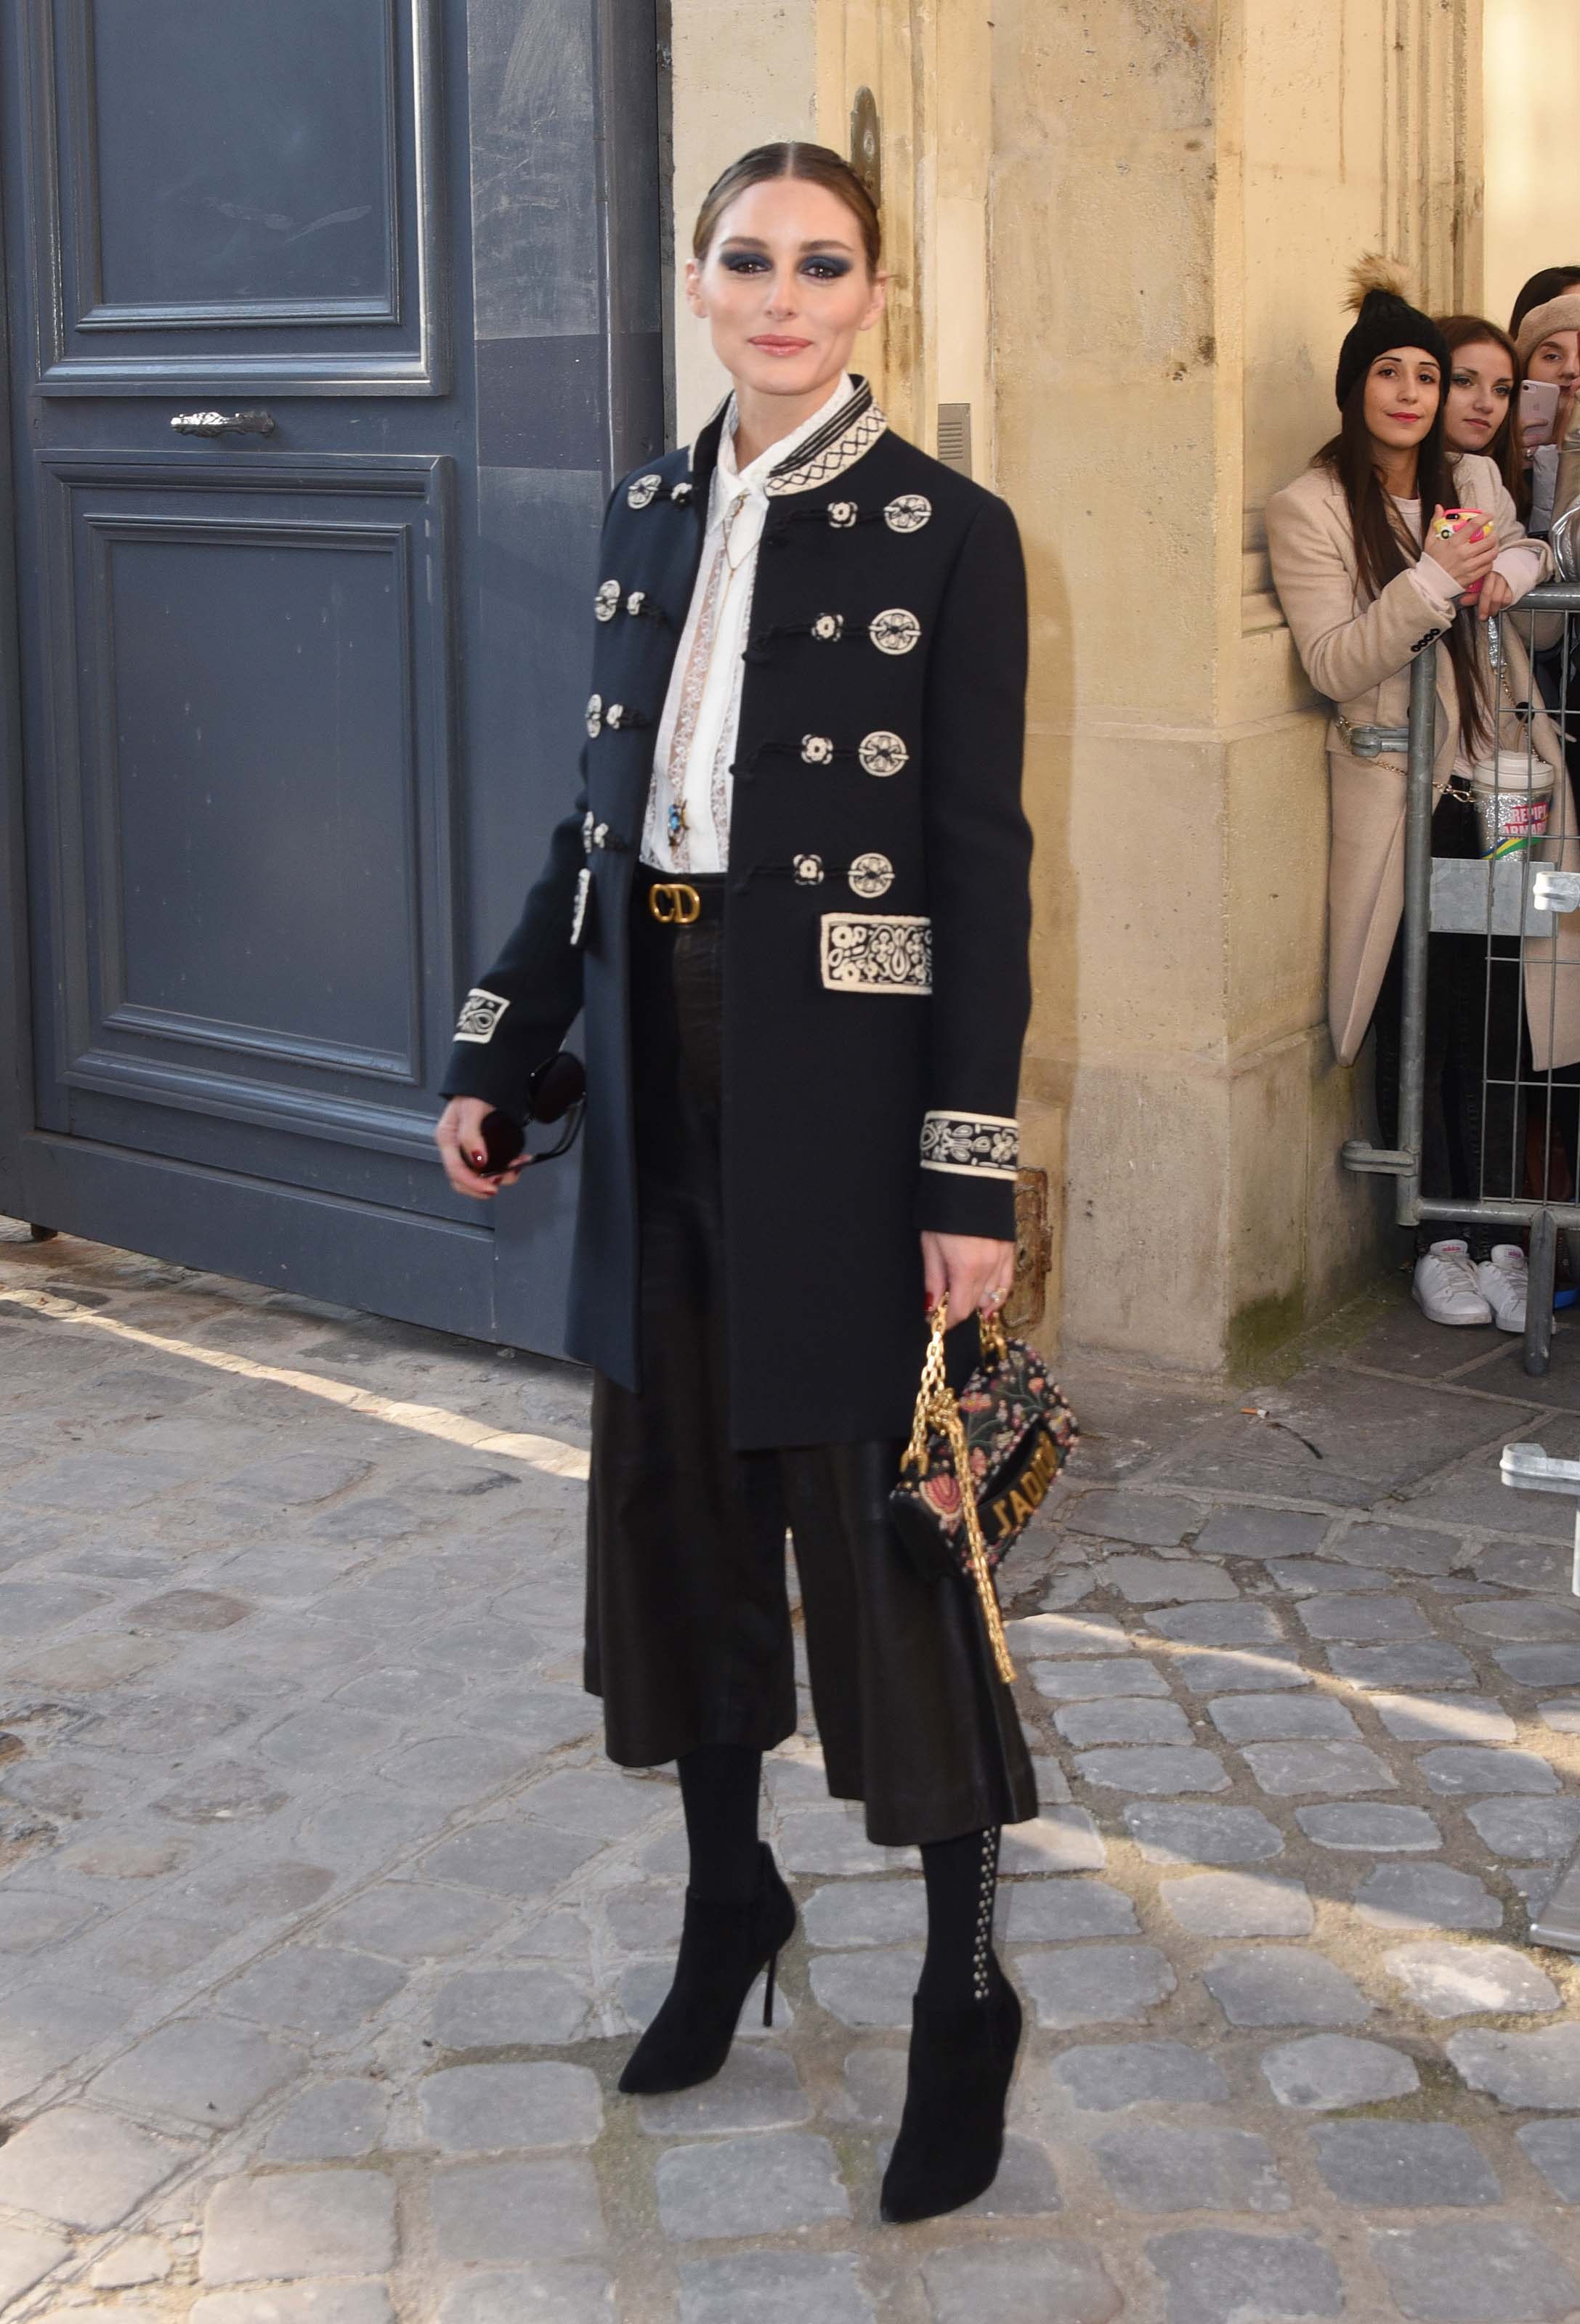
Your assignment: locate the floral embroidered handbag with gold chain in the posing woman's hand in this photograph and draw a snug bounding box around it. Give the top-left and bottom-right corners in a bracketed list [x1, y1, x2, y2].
[890, 1299, 1080, 1683]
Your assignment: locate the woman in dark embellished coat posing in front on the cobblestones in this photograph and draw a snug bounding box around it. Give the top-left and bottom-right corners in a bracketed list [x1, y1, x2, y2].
[437, 144, 1037, 2219]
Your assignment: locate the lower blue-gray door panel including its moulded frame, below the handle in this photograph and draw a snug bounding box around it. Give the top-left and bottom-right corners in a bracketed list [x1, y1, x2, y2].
[44, 455, 453, 1134]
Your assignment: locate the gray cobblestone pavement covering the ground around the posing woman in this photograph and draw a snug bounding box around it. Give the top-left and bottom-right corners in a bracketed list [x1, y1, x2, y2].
[0, 1224, 1580, 2324]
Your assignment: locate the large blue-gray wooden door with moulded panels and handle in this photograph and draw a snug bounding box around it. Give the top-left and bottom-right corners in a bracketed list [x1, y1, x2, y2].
[0, 0, 663, 1350]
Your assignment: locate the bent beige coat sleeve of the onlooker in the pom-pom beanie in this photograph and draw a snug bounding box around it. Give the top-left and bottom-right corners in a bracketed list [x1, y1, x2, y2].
[1266, 486, 1449, 702]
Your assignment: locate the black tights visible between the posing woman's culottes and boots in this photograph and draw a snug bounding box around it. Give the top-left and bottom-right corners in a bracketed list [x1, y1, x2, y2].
[678, 1743, 999, 2008]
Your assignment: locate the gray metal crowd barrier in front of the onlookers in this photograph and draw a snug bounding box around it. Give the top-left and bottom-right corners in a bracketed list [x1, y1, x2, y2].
[1343, 583, 1580, 1376]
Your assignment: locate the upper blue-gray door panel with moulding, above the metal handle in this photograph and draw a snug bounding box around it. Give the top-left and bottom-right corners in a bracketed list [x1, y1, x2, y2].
[25, 0, 444, 395]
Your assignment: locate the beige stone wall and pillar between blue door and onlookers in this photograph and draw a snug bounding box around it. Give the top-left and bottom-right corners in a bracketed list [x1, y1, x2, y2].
[674, 0, 1480, 1373]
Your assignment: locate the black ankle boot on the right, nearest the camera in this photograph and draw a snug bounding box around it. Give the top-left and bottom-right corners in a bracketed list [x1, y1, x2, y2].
[880, 1962, 1020, 2227]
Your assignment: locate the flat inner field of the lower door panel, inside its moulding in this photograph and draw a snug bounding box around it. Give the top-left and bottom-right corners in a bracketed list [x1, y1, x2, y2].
[108, 519, 418, 1060]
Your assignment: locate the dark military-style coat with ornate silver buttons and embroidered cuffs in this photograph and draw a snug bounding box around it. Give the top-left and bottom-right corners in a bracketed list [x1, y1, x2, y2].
[444, 383, 1032, 1448]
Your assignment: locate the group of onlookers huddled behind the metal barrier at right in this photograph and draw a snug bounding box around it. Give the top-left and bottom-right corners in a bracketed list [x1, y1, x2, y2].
[1266, 260, 1580, 1332]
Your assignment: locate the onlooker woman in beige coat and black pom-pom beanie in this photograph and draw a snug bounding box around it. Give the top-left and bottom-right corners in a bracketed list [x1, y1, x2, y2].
[1266, 261, 1580, 1329]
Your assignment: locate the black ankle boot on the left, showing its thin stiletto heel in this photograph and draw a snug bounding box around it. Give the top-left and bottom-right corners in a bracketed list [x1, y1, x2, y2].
[620, 1843, 795, 2096]
